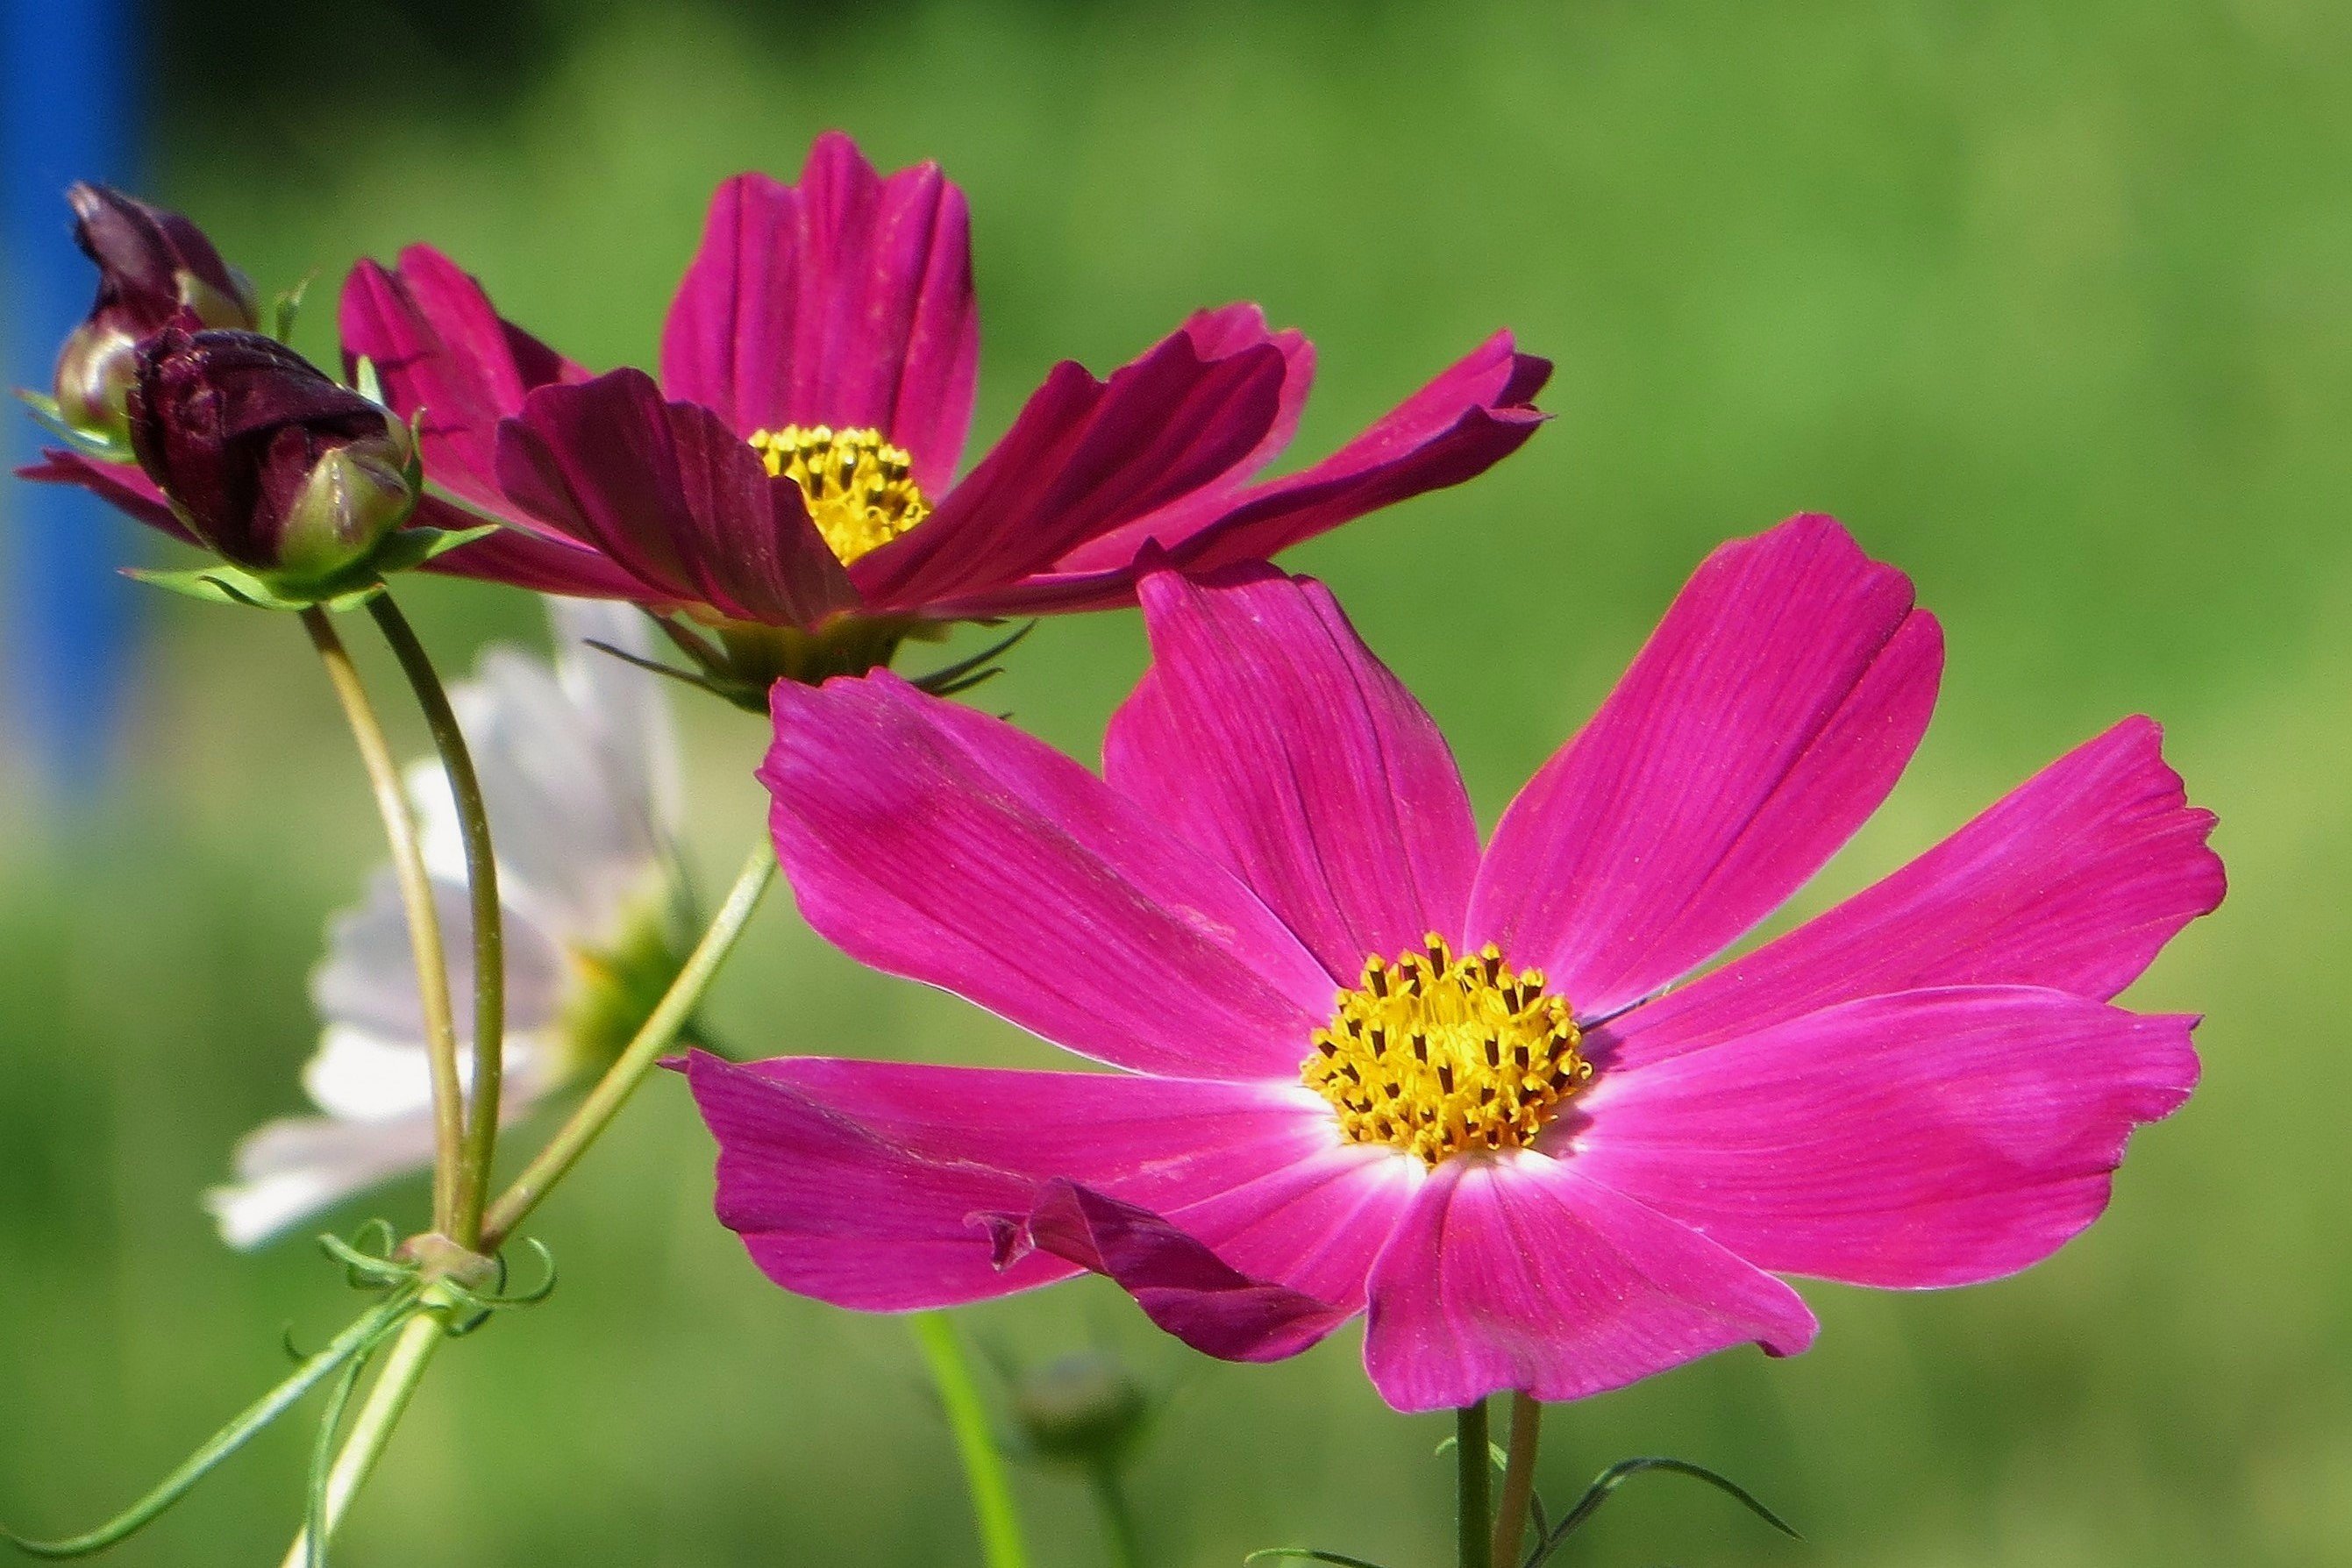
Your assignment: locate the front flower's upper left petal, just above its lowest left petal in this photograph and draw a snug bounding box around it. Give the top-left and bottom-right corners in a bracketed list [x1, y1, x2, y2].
[759, 673, 1331, 1081]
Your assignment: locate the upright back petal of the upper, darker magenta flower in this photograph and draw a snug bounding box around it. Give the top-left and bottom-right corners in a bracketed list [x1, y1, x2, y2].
[661, 132, 980, 496]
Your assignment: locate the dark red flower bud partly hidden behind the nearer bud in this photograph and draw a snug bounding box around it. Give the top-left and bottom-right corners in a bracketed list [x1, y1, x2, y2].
[56, 183, 261, 435]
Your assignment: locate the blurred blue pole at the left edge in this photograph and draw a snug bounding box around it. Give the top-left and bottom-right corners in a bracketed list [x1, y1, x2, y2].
[0, 0, 137, 799]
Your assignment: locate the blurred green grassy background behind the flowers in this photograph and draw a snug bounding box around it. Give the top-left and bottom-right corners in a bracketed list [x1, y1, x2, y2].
[0, 0, 2352, 1568]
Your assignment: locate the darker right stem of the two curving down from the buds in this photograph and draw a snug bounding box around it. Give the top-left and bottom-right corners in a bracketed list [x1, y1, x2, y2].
[367, 590, 506, 1248]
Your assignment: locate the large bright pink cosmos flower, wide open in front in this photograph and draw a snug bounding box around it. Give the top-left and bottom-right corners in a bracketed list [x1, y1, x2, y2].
[689, 517, 2222, 1410]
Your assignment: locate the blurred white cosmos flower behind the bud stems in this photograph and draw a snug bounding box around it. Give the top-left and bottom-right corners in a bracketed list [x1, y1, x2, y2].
[204, 600, 682, 1248]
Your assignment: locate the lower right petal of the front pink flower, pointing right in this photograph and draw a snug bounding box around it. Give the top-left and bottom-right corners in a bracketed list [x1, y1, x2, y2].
[1569, 987, 2197, 1288]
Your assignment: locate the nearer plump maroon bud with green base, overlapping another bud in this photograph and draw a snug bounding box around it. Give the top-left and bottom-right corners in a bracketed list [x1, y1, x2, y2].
[130, 327, 417, 583]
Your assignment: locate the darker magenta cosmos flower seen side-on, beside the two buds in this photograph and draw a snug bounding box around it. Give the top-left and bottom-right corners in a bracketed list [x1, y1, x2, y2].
[312, 134, 1550, 691]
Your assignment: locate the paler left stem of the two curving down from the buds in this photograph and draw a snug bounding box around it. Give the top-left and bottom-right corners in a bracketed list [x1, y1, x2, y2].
[301, 607, 466, 1232]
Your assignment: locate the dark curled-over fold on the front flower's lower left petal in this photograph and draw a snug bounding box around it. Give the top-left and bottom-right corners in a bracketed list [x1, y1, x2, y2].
[987, 1180, 1358, 1361]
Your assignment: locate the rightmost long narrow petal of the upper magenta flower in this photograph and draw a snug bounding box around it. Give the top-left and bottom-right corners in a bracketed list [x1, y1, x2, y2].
[973, 331, 1552, 616]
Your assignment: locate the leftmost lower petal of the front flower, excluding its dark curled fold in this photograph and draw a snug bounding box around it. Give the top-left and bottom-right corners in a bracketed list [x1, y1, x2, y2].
[687, 1056, 1386, 1309]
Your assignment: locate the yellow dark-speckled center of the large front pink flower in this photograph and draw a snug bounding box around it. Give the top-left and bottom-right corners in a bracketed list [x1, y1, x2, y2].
[1298, 931, 1593, 1166]
